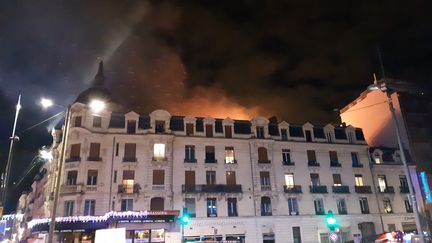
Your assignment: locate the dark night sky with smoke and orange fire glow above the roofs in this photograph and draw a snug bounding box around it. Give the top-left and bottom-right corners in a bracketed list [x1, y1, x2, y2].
[0, 0, 432, 211]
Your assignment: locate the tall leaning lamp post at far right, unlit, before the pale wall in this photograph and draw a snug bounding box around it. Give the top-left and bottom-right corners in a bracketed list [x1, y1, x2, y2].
[368, 80, 425, 243]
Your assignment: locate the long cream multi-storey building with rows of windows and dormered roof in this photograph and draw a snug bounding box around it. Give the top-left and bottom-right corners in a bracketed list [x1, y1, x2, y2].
[22, 102, 420, 242]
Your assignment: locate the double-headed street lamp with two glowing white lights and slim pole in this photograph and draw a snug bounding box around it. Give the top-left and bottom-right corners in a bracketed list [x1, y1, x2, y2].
[45, 99, 105, 243]
